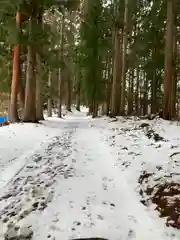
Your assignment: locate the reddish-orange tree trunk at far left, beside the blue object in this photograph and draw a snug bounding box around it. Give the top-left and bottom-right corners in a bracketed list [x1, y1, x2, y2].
[8, 12, 22, 122]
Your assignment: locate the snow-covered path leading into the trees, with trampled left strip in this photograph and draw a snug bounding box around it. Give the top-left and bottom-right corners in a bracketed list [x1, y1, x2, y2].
[0, 111, 178, 240]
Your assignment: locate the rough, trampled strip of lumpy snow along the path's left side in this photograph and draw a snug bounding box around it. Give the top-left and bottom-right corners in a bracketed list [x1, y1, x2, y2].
[0, 125, 75, 232]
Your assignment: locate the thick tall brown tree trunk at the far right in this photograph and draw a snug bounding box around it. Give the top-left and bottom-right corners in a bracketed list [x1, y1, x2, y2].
[163, 0, 174, 120]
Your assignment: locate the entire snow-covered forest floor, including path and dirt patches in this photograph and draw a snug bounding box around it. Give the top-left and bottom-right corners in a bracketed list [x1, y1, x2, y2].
[0, 108, 180, 240]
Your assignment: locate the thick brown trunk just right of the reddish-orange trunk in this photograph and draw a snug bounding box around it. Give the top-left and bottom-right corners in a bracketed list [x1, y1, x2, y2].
[23, 43, 37, 122]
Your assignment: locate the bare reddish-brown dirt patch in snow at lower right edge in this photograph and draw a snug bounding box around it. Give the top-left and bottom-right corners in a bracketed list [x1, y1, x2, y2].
[139, 171, 180, 229]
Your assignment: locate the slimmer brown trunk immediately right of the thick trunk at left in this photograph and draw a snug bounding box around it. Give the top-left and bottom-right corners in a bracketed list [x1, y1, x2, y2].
[36, 53, 44, 121]
